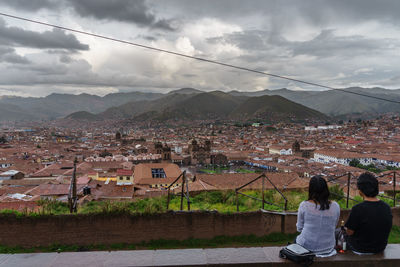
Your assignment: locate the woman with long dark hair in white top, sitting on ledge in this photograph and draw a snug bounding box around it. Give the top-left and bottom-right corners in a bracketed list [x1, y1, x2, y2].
[296, 175, 340, 256]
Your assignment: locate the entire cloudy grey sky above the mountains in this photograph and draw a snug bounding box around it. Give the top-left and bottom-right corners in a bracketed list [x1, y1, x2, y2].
[0, 0, 400, 96]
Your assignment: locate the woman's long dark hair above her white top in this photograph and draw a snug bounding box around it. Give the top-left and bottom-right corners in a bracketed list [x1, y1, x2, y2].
[308, 175, 331, 210]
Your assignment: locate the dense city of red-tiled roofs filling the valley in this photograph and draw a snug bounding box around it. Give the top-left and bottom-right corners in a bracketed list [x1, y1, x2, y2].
[0, 115, 400, 214]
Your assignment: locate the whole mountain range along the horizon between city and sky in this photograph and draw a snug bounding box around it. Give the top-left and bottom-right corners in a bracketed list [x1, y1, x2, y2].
[0, 87, 400, 121]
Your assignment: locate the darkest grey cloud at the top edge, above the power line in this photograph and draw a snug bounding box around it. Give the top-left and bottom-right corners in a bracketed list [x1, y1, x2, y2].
[68, 0, 174, 31]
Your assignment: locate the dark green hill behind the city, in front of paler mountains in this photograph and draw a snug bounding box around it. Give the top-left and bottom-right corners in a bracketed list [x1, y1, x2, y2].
[90, 91, 328, 121]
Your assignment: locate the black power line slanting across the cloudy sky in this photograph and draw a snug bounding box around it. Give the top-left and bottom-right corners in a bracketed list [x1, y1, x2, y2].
[0, 12, 400, 104]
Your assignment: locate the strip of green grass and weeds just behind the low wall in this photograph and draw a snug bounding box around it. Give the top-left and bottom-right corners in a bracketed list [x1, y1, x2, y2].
[0, 188, 393, 217]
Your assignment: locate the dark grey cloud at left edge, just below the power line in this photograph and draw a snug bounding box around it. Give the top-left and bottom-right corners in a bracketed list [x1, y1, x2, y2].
[0, 19, 89, 50]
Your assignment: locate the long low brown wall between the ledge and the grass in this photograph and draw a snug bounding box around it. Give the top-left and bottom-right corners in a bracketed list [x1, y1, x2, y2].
[0, 208, 400, 247]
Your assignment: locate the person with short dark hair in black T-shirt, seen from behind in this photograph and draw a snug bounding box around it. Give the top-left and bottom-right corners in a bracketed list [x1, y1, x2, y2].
[345, 172, 393, 253]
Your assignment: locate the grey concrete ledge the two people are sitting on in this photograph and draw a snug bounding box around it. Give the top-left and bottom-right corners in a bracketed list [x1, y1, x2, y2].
[0, 245, 400, 267]
